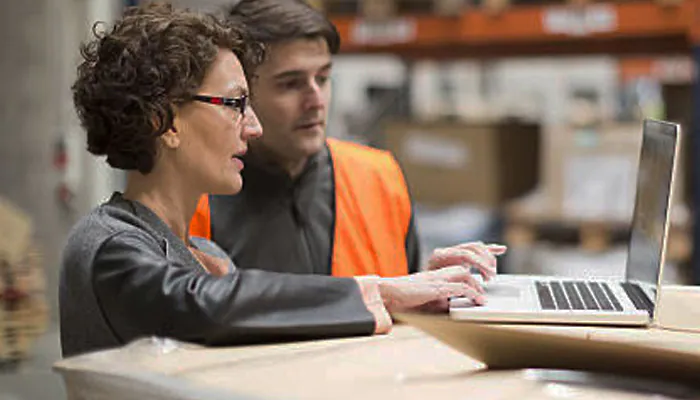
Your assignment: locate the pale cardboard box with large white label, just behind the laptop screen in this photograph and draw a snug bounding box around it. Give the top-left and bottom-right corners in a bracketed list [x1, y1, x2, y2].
[543, 122, 685, 223]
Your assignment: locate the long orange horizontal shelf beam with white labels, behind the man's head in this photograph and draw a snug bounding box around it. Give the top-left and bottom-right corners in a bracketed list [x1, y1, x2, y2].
[332, 0, 700, 57]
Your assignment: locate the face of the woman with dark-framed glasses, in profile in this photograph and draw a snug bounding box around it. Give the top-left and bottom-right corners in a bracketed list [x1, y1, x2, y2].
[173, 49, 262, 194]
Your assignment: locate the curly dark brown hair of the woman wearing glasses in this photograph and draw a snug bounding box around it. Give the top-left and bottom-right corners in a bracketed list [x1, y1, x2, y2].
[72, 4, 262, 174]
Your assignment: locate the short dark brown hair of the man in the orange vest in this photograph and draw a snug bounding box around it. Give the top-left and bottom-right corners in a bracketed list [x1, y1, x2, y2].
[228, 0, 340, 54]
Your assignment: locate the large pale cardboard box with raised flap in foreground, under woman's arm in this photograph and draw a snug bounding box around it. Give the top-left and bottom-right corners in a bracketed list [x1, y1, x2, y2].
[55, 322, 700, 400]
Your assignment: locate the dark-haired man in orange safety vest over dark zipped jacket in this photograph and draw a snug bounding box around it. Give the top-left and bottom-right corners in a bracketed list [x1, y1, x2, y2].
[190, 0, 504, 276]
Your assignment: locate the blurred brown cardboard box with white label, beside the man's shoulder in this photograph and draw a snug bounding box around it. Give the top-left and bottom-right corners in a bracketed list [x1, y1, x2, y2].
[383, 121, 540, 206]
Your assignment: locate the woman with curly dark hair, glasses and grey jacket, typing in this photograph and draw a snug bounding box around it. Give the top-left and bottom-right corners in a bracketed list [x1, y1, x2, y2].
[60, 6, 503, 356]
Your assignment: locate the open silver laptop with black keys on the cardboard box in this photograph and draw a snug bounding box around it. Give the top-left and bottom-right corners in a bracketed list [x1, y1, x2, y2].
[450, 120, 680, 325]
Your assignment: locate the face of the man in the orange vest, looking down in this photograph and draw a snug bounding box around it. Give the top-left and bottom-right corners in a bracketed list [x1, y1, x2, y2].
[251, 38, 331, 162]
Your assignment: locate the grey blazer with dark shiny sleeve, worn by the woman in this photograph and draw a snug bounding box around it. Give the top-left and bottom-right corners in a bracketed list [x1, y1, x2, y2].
[59, 193, 375, 356]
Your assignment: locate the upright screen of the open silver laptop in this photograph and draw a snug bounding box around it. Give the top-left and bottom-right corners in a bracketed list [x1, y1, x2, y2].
[627, 120, 678, 286]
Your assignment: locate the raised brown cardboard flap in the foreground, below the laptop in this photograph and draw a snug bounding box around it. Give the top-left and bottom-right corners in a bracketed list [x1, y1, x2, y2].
[396, 314, 700, 386]
